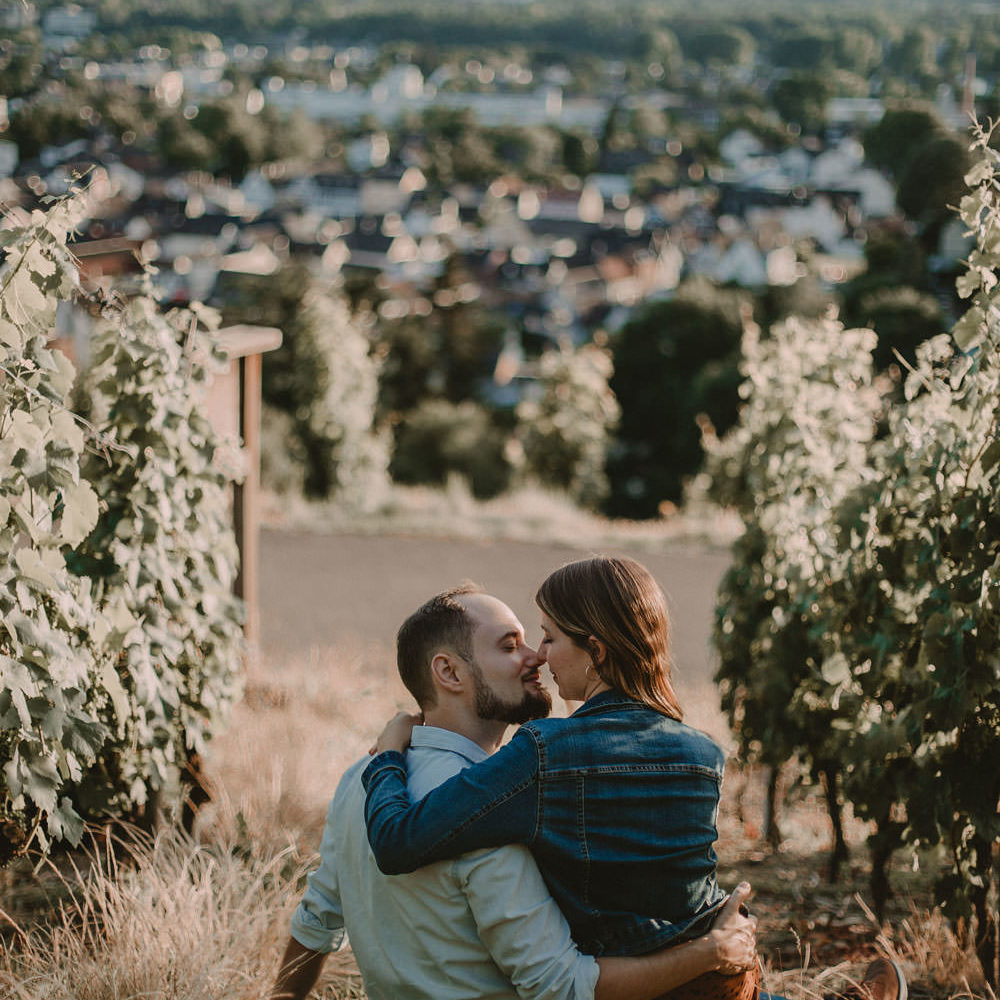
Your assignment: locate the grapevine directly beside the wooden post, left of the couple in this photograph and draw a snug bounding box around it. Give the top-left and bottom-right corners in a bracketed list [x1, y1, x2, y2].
[69, 284, 242, 818]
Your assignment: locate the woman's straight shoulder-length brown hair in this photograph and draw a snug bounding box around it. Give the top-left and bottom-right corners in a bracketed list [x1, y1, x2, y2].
[535, 556, 684, 721]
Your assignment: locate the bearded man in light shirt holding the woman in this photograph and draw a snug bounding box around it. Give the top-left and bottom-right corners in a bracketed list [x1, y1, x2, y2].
[272, 586, 756, 1000]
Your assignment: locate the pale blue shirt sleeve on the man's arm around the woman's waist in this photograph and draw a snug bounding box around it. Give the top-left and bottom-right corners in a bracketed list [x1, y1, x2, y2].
[455, 846, 600, 1000]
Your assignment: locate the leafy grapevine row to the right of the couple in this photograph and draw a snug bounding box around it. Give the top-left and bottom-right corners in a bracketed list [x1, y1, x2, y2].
[709, 119, 1000, 988]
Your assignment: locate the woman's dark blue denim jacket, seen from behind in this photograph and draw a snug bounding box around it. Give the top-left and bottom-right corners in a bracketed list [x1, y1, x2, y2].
[362, 691, 725, 955]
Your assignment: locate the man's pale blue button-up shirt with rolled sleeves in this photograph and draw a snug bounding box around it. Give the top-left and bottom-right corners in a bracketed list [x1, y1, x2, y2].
[291, 726, 599, 1000]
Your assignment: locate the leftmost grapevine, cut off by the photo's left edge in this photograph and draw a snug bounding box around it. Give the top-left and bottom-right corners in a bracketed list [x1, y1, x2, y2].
[0, 203, 111, 861]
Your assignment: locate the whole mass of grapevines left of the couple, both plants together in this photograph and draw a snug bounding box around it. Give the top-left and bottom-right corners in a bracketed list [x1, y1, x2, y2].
[0, 195, 247, 861]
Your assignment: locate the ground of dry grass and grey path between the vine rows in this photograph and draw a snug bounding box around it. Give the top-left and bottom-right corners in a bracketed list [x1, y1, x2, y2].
[0, 516, 987, 1000]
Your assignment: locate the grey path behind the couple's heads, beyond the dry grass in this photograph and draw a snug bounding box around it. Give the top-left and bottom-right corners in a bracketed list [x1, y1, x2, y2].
[260, 530, 728, 736]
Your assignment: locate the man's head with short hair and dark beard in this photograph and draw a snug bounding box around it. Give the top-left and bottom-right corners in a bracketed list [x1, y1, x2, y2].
[396, 584, 552, 725]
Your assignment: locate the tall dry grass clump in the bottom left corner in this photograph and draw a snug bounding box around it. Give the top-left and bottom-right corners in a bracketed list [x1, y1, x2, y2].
[0, 830, 302, 1000]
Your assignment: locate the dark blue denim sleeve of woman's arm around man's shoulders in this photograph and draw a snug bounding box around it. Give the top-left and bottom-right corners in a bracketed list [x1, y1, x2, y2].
[361, 729, 538, 875]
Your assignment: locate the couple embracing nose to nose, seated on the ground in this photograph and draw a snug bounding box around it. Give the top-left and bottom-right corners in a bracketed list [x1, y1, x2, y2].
[272, 557, 906, 1000]
